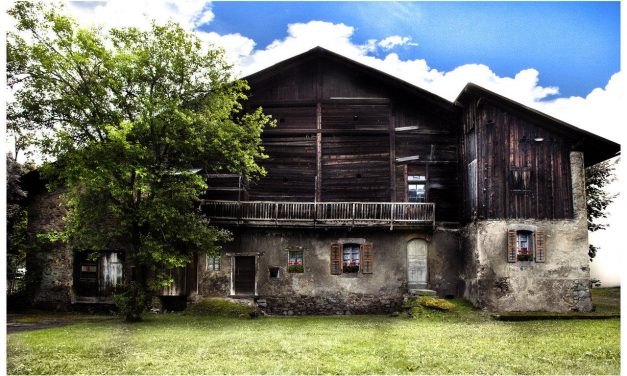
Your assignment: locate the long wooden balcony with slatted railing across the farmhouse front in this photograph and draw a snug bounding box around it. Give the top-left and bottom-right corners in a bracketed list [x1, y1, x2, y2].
[202, 200, 435, 229]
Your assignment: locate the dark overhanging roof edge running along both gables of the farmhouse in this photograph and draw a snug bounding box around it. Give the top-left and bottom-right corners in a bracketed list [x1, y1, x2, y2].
[244, 47, 620, 166]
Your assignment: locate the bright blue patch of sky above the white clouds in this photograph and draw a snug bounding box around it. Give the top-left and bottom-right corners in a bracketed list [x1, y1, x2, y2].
[201, 2, 620, 96]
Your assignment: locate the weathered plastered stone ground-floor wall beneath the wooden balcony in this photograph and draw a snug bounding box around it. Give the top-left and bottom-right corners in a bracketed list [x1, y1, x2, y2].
[198, 228, 459, 314]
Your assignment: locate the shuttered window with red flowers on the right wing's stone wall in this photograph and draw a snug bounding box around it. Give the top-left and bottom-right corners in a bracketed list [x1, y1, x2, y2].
[507, 226, 546, 262]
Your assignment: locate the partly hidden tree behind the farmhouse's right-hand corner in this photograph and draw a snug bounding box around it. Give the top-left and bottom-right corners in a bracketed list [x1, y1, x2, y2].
[586, 160, 618, 261]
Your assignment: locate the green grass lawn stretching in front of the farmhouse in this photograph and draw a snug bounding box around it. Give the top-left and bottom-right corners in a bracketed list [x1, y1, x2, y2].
[7, 290, 620, 374]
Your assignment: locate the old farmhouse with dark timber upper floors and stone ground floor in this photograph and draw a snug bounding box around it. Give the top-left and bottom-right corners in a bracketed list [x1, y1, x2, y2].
[24, 48, 619, 314]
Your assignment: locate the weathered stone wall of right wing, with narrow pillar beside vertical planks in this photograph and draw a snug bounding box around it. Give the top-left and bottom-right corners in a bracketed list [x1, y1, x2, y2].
[461, 152, 592, 312]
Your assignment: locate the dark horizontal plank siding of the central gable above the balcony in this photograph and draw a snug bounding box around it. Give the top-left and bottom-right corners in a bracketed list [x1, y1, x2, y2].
[248, 54, 461, 221]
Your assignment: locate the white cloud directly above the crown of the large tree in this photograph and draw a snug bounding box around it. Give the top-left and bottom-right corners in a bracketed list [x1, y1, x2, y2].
[67, 0, 214, 30]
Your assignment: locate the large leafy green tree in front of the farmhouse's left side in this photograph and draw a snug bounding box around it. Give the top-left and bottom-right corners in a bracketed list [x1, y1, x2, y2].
[7, 2, 272, 320]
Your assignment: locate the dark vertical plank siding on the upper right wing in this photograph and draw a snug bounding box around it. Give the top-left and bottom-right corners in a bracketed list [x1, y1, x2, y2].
[462, 100, 573, 219]
